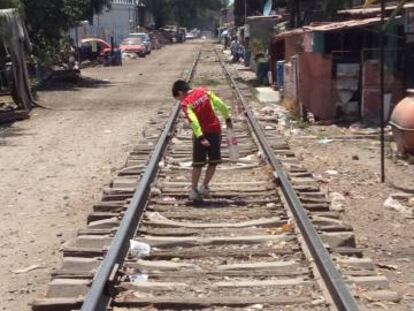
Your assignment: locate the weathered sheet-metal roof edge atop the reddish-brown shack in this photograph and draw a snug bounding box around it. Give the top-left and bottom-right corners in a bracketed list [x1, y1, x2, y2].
[275, 17, 381, 39]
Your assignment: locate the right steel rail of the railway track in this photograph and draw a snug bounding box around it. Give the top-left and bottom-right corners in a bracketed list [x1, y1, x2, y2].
[215, 49, 359, 311]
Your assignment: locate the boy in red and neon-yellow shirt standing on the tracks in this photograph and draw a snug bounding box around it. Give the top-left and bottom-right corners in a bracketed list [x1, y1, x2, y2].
[172, 80, 233, 201]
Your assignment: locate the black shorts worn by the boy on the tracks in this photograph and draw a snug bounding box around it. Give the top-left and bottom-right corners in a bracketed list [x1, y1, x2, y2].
[193, 134, 221, 167]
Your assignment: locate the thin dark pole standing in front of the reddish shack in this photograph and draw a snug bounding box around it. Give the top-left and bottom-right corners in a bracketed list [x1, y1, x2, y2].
[380, 0, 385, 183]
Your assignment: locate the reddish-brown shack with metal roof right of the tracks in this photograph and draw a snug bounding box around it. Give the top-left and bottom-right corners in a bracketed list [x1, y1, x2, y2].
[268, 3, 414, 123]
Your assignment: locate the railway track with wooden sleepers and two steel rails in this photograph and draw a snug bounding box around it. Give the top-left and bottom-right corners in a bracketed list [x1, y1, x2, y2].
[33, 44, 406, 311]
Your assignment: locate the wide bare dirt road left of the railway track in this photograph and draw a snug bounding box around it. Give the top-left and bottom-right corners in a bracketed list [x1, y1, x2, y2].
[0, 44, 196, 311]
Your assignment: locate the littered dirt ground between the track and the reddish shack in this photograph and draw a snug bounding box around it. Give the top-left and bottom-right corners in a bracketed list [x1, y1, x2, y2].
[290, 126, 414, 310]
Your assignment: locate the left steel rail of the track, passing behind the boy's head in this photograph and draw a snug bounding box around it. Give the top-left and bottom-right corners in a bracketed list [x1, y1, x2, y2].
[81, 50, 201, 311]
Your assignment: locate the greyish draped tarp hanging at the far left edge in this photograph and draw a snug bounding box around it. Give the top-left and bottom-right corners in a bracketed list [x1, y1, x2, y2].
[0, 9, 35, 111]
